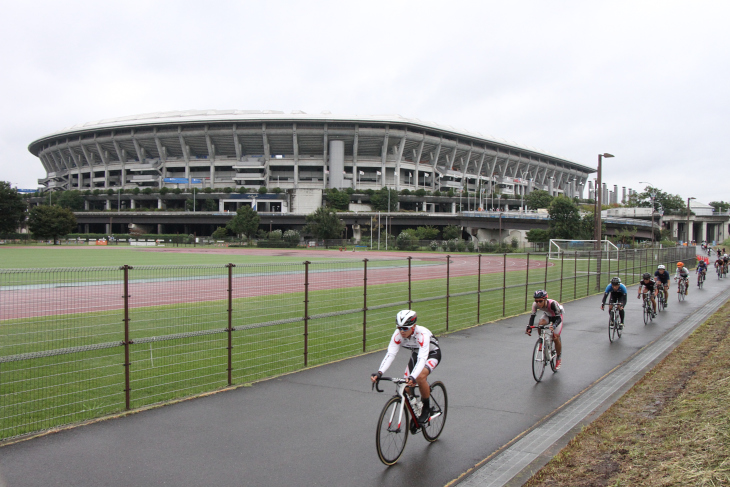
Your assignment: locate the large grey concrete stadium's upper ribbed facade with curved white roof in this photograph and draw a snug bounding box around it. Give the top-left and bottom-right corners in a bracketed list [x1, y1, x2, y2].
[29, 110, 595, 211]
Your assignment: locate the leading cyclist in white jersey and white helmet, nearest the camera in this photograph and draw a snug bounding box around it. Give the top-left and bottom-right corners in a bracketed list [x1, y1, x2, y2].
[370, 309, 441, 424]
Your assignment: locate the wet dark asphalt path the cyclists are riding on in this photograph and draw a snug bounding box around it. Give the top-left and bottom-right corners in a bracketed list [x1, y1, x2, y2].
[0, 273, 730, 487]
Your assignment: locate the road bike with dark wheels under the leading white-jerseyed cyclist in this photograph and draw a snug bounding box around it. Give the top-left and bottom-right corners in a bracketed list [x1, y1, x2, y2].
[373, 377, 449, 465]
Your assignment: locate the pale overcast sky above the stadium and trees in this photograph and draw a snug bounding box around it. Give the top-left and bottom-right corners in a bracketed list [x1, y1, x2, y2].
[0, 0, 730, 202]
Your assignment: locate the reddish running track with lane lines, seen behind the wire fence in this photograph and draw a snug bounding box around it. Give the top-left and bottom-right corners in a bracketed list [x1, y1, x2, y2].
[0, 249, 553, 320]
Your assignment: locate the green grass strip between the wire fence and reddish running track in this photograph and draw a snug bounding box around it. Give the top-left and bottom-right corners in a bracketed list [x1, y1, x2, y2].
[0, 249, 692, 438]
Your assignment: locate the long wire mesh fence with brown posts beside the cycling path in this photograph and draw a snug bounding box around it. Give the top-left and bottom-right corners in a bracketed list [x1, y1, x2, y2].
[0, 247, 695, 439]
